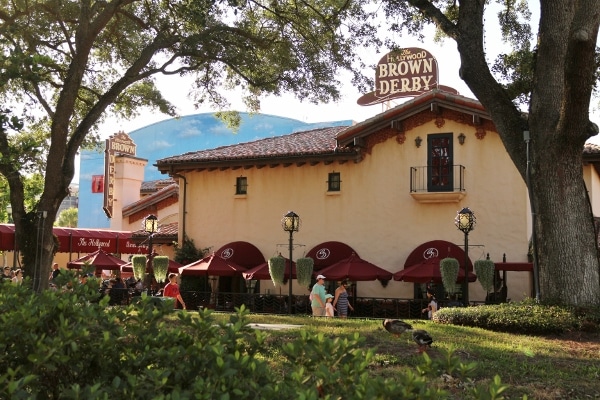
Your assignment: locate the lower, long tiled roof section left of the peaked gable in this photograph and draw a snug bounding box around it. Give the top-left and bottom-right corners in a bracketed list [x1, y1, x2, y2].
[156, 126, 356, 173]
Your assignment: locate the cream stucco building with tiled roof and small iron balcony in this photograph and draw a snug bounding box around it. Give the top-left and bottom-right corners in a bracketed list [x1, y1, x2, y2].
[151, 90, 600, 301]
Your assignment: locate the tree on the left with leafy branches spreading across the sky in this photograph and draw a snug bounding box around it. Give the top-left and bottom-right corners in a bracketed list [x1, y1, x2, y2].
[0, 0, 376, 288]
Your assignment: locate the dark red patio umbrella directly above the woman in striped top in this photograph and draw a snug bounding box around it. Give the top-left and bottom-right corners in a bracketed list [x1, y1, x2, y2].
[314, 254, 393, 281]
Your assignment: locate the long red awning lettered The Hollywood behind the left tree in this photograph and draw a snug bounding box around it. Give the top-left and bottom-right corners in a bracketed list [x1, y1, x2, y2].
[0, 224, 139, 254]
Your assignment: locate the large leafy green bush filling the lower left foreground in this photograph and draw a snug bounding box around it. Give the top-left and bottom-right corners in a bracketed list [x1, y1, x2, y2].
[0, 280, 516, 400]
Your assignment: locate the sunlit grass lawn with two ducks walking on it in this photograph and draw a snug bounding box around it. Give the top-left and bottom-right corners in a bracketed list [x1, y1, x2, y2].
[207, 313, 600, 400]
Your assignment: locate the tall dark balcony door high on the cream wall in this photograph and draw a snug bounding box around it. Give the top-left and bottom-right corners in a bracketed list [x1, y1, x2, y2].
[427, 133, 454, 192]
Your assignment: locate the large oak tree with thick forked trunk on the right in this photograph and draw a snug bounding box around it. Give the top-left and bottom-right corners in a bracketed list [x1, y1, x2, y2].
[384, 0, 600, 305]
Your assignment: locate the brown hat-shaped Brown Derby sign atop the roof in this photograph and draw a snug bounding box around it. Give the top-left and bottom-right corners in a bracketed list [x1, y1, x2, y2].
[358, 47, 438, 105]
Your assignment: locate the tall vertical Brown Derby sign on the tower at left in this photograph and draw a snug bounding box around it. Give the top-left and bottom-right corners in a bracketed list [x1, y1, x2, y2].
[102, 132, 136, 218]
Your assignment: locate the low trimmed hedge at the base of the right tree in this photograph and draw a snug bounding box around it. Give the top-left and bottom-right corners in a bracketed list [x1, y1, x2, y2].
[433, 300, 600, 335]
